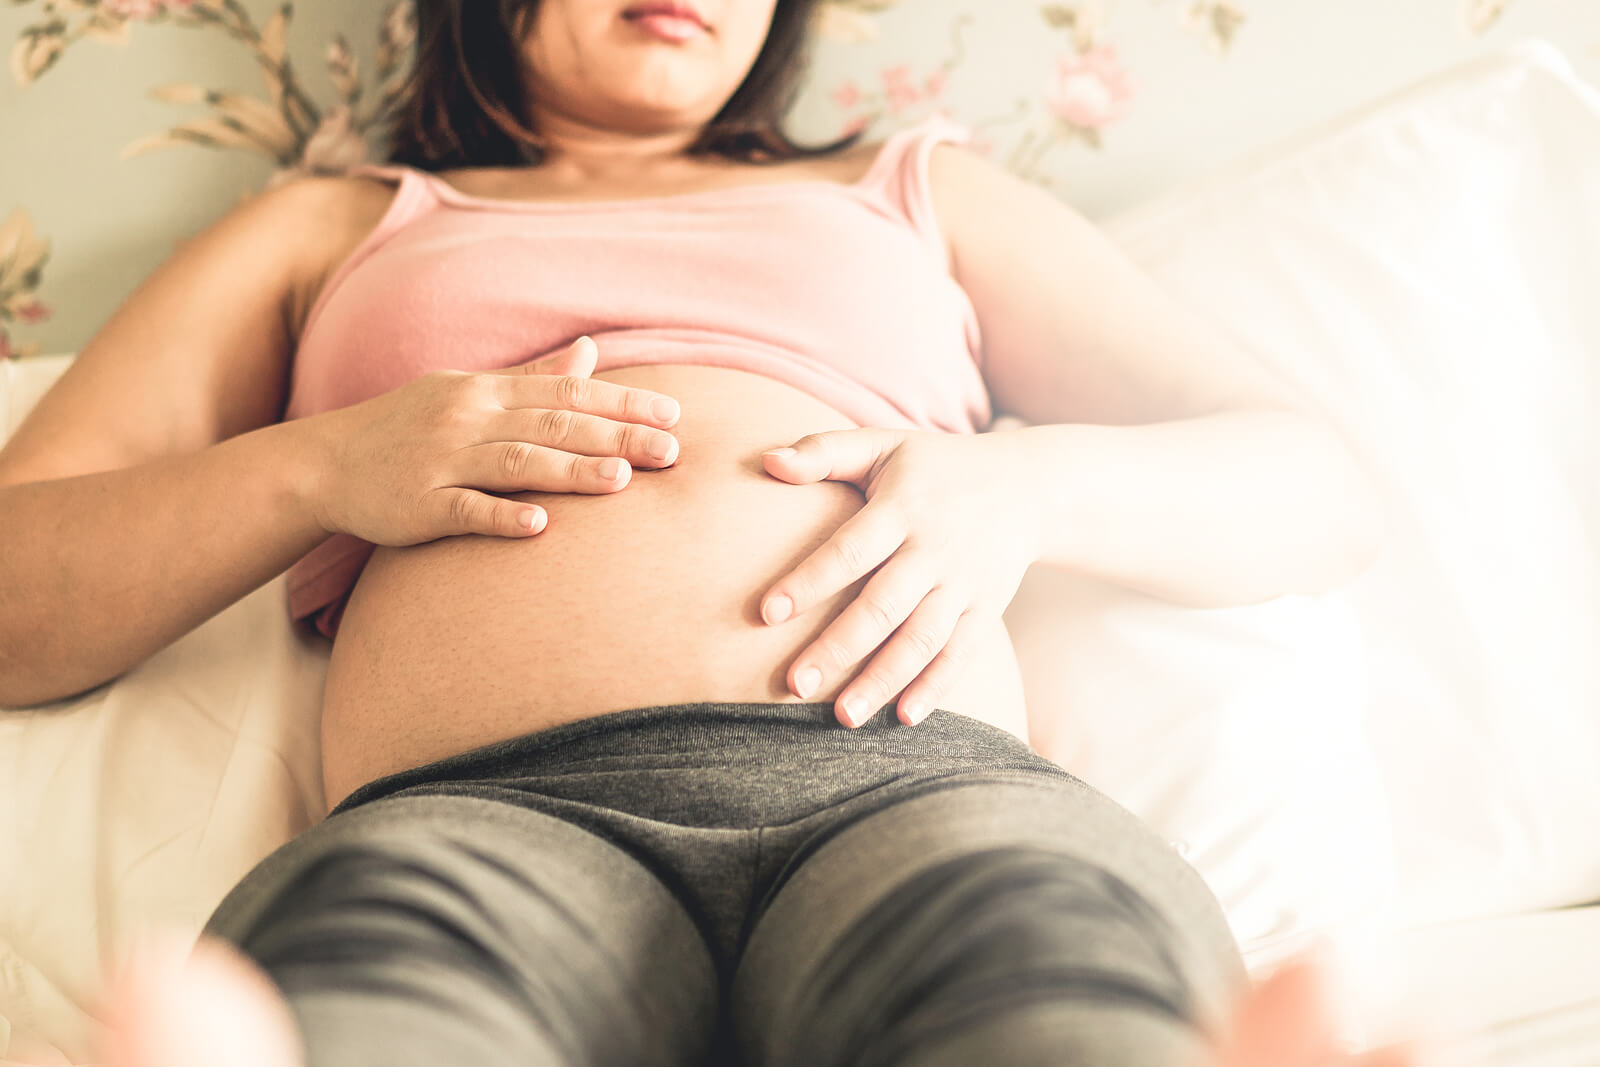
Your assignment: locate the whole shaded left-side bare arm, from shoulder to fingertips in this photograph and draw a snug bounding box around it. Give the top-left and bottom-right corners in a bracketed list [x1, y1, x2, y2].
[0, 168, 677, 705]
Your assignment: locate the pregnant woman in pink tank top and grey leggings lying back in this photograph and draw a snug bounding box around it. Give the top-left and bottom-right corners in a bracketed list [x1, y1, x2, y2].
[0, 0, 1411, 1067]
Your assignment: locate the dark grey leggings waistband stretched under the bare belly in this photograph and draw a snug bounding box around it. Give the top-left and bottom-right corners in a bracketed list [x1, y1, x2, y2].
[330, 701, 1075, 829]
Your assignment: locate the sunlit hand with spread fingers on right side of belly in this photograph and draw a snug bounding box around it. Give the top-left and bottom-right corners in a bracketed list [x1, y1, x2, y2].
[762, 429, 1038, 726]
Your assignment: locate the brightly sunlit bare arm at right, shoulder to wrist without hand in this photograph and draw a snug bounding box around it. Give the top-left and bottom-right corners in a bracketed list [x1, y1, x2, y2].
[930, 146, 1384, 606]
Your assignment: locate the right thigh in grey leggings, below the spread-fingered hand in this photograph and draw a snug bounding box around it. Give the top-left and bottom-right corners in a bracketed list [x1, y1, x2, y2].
[730, 774, 1246, 1067]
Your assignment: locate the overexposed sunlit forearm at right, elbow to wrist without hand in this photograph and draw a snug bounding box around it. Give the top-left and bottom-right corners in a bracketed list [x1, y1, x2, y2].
[1011, 410, 1381, 608]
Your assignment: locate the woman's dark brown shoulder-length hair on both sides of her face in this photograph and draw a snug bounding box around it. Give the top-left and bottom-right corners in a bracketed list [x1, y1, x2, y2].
[380, 0, 861, 171]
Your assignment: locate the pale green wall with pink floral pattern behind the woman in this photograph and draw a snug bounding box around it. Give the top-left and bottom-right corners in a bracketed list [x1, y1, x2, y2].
[0, 0, 1600, 352]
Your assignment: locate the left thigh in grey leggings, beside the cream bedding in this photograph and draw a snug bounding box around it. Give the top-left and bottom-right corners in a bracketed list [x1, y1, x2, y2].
[206, 795, 717, 1067]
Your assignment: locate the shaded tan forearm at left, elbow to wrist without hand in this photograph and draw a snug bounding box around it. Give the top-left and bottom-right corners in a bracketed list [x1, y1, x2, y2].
[0, 422, 328, 707]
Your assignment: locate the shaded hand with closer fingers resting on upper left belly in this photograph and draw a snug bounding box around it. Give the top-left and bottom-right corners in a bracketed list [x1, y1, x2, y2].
[307, 338, 678, 547]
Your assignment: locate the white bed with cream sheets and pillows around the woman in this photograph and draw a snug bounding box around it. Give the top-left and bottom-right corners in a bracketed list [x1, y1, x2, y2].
[0, 42, 1600, 1067]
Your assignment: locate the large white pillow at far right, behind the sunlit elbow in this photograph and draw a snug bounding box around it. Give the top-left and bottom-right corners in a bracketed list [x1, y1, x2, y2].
[1088, 42, 1600, 934]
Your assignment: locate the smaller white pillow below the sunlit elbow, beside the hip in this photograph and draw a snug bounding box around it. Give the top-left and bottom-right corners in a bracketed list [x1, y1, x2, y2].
[1005, 566, 1394, 974]
